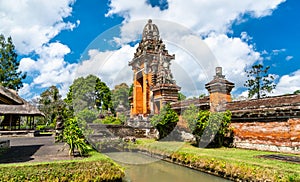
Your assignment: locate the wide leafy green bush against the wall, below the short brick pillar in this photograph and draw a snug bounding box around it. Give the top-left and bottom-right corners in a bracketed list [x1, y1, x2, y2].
[182, 105, 231, 147]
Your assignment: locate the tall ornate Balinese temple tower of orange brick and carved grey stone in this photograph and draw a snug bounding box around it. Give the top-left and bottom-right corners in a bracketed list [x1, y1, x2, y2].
[129, 20, 180, 117]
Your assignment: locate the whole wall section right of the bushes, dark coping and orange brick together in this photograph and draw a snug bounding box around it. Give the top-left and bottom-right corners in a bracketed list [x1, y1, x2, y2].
[227, 95, 300, 153]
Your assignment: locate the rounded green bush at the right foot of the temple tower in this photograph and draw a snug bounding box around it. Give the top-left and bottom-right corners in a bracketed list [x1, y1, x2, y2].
[150, 104, 179, 139]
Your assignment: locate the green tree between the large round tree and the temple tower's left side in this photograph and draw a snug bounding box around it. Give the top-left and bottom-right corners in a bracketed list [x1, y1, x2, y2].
[112, 83, 130, 109]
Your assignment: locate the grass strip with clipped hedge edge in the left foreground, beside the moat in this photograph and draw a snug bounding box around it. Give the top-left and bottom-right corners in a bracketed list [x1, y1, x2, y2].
[0, 151, 125, 182]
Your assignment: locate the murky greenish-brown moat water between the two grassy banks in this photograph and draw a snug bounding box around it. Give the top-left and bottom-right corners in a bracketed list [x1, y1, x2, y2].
[106, 152, 228, 182]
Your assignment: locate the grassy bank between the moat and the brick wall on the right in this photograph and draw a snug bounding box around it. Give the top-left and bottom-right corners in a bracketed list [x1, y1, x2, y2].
[135, 140, 300, 181]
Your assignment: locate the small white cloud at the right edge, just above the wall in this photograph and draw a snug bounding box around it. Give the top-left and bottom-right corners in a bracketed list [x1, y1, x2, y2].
[271, 70, 300, 95]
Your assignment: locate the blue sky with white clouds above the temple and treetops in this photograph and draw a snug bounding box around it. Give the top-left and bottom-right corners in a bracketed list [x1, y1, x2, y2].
[0, 0, 300, 99]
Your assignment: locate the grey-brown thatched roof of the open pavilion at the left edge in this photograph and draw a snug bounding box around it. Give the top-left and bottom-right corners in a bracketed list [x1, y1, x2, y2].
[0, 85, 44, 116]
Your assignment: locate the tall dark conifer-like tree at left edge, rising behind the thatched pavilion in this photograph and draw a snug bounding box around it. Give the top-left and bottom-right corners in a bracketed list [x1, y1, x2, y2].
[0, 34, 26, 90]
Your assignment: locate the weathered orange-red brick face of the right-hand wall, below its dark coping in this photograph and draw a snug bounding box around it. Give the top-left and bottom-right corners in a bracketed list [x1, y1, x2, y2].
[231, 118, 300, 153]
